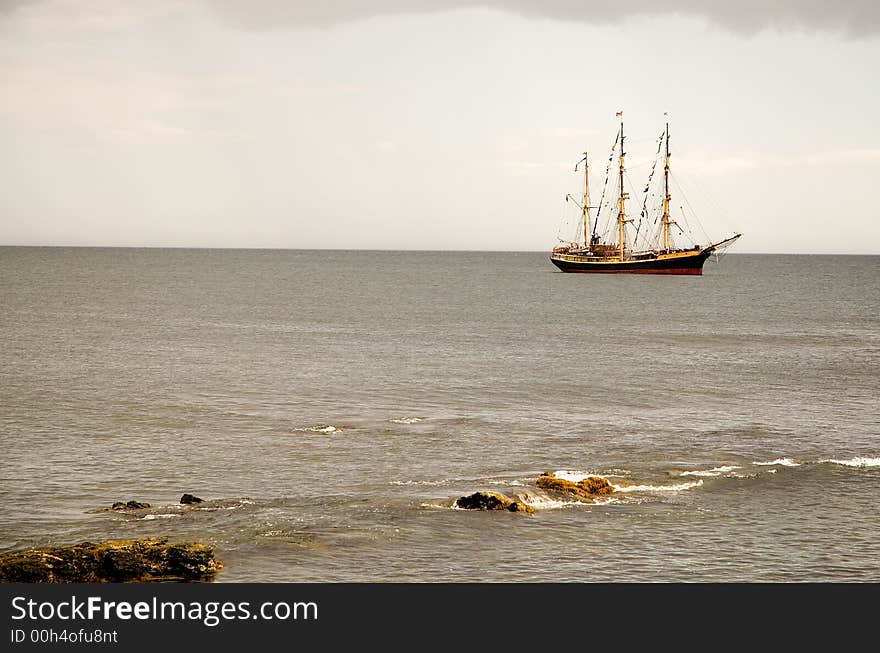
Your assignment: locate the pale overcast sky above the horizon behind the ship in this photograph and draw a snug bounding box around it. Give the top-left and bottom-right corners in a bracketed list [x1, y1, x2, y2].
[0, 0, 880, 254]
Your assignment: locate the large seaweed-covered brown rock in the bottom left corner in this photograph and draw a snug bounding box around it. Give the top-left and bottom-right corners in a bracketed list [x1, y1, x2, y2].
[0, 537, 223, 583]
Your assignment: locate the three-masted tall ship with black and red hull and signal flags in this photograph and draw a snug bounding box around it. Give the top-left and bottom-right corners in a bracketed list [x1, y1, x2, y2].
[550, 112, 742, 274]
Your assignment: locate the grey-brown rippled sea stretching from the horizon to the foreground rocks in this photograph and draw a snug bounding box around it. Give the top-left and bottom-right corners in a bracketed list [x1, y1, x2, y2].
[0, 247, 880, 583]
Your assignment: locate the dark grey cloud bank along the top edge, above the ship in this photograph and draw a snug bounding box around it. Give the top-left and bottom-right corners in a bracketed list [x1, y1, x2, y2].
[203, 0, 880, 36]
